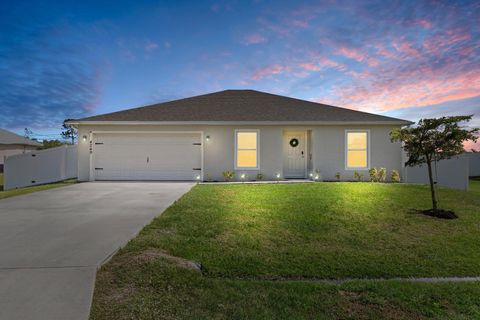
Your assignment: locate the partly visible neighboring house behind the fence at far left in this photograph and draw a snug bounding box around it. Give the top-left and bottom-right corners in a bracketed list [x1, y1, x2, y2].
[0, 128, 42, 172]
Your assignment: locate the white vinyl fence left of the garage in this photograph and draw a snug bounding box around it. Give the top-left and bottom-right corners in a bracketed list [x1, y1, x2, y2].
[3, 146, 77, 190]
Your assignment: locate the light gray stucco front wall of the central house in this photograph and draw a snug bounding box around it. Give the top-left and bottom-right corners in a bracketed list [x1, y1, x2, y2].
[78, 125, 402, 181]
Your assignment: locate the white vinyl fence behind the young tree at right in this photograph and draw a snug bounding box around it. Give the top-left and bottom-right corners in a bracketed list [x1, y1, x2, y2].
[404, 154, 469, 190]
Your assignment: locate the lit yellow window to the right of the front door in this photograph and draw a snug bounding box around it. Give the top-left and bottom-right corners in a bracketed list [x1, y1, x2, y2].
[346, 131, 368, 169]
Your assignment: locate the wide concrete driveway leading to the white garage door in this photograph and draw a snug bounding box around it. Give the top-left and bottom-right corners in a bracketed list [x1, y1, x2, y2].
[0, 182, 194, 320]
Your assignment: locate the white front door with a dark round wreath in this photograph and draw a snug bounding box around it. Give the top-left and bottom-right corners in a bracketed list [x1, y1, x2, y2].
[283, 132, 307, 178]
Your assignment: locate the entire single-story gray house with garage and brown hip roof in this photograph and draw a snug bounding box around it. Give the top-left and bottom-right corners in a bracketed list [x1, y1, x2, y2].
[70, 90, 411, 181]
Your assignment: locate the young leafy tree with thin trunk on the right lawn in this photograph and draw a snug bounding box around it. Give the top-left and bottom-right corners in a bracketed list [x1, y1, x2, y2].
[390, 116, 479, 211]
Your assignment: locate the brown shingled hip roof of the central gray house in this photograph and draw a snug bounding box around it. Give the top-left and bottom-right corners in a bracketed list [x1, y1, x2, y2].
[70, 90, 411, 124]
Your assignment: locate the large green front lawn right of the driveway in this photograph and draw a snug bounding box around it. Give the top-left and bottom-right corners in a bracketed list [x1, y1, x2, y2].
[91, 183, 480, 319]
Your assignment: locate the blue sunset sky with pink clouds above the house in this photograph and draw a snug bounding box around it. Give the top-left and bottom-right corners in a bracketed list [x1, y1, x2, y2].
[0, 0, 480, 149]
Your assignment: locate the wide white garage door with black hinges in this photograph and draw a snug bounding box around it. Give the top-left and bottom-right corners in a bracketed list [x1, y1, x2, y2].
[93, 133, 202, 180]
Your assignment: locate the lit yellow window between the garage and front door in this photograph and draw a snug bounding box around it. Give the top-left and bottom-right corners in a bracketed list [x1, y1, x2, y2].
[235, 130, 258, 169]
